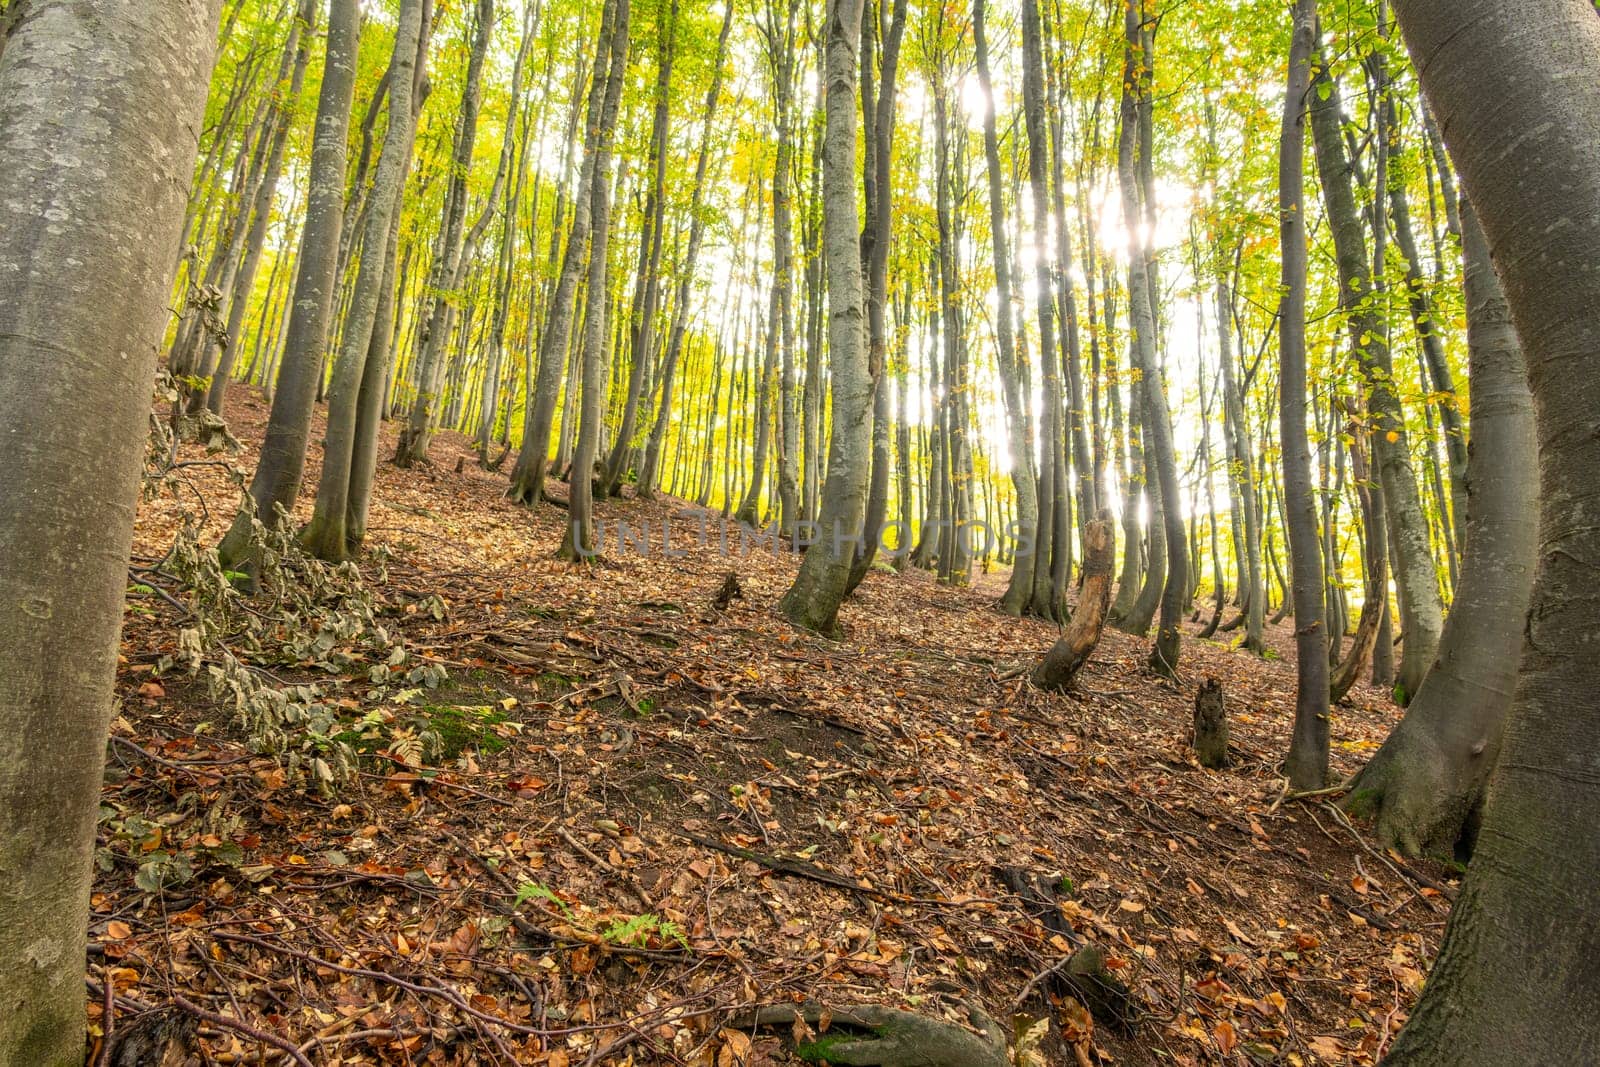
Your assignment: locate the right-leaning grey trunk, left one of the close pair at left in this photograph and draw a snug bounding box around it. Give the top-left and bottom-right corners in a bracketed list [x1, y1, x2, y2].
[218, 0, 360, 566]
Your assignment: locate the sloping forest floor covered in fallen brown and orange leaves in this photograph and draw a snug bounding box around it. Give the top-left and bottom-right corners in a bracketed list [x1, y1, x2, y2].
[88, 386, 1454, 1067]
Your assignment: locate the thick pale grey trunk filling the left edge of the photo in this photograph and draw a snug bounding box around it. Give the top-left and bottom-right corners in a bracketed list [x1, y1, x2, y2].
[0, 0, 218, 1067]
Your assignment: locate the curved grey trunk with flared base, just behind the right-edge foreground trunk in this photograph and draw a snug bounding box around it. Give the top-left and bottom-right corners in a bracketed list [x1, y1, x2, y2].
[1346, 202, 1539, 857]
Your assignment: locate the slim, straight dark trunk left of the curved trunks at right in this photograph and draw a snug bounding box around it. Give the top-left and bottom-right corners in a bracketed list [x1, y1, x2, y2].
[1278, 0, 1328, 792]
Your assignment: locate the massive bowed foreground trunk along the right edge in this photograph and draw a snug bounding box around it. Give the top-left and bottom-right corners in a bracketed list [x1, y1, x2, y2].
[1387, 0, 1600, 1065]
